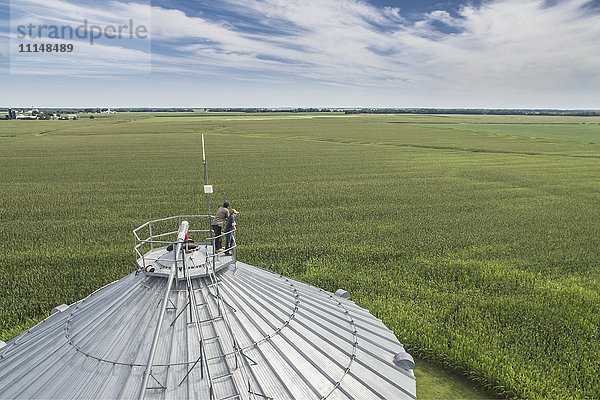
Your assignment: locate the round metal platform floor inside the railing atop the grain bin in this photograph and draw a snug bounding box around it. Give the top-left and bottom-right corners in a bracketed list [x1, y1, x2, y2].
[137, 244, 235, 280]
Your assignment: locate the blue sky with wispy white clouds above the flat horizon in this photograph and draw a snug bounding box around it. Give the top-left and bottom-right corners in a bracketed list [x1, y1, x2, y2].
[0, 0, 600, 109]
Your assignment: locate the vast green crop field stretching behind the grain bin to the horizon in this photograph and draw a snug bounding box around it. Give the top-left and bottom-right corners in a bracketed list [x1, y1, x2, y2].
[0, 113, 600, 399]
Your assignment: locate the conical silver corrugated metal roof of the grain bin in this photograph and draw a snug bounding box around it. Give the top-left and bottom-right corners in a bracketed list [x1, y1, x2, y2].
[0, 262, 416, 399]
